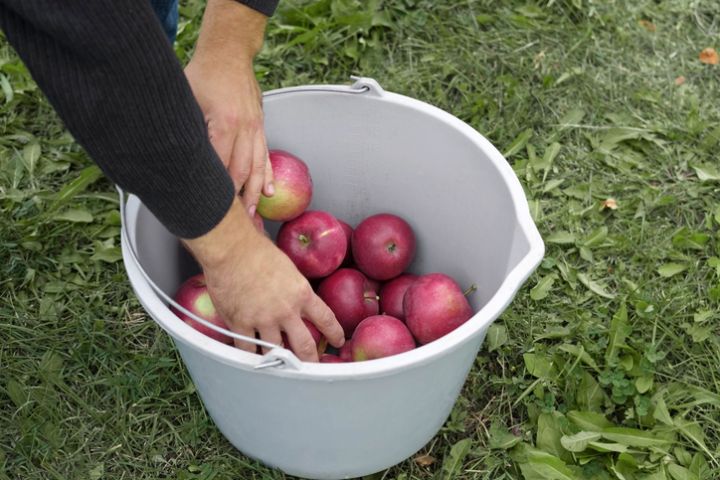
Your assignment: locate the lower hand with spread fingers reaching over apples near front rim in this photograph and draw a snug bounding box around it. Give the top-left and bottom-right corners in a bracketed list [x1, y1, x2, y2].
[184, 199, 345, 362]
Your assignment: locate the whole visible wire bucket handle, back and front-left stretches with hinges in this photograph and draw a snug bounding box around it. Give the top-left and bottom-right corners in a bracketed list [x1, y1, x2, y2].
[115, 76, 384, 370]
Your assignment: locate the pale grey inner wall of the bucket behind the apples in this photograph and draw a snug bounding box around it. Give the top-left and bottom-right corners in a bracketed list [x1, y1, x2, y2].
[135, 91, 530, 318]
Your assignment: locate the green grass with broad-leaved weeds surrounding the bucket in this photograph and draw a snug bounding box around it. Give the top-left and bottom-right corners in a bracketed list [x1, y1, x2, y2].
[0, 0, 720, 480]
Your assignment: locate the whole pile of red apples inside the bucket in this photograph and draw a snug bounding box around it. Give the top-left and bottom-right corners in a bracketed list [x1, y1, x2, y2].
[175, 150, 473, 363]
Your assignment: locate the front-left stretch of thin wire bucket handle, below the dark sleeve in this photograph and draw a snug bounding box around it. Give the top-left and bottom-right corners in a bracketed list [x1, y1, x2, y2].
[115, 185, 302, 370]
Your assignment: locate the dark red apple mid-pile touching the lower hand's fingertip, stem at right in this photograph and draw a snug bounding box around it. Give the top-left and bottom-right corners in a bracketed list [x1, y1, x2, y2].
[317, 268, 378, 338]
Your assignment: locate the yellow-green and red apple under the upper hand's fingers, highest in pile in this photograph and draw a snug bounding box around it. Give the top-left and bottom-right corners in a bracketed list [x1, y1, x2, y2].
[257, 150, 313, 222]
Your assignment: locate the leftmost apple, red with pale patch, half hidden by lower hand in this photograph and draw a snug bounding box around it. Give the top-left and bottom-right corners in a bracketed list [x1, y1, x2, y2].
[170, 273, 233, 345]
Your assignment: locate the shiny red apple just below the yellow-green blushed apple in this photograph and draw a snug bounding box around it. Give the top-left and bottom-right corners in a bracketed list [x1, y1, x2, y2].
[277, 211, 347, 278]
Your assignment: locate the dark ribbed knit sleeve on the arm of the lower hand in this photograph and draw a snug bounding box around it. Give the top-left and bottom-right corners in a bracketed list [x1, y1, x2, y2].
[0, 0, 236, 238]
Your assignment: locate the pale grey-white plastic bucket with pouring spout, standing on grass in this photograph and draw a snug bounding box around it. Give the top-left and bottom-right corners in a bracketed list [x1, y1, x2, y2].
[122, 78, 544, 479]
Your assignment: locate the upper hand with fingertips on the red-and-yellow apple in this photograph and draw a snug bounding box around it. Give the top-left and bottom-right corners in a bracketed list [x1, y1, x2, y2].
[185, 0, 274, 216]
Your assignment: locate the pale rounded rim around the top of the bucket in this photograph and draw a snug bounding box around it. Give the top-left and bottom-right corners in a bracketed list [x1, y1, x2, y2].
[121, 80, 545, 380]
